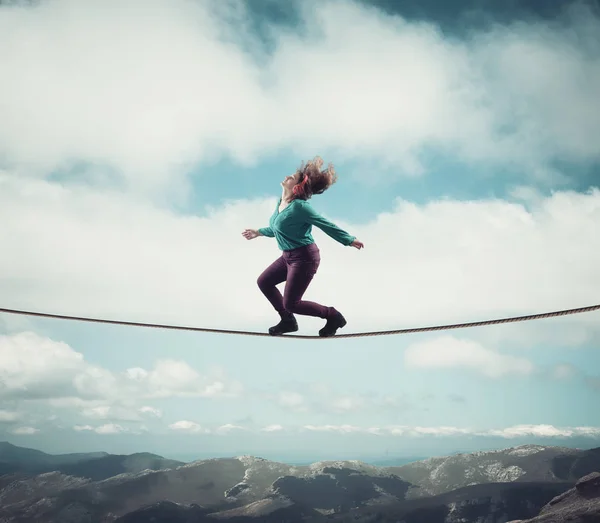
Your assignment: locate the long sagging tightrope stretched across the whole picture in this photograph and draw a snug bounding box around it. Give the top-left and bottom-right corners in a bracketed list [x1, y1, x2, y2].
[0, 305, 600, 340]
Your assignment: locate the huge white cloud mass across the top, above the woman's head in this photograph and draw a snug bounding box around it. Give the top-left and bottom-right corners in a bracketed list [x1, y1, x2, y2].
[0, 0, 600, 198]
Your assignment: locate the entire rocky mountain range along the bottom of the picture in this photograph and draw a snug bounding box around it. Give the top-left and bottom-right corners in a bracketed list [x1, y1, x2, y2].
[0, 443, 600, 523]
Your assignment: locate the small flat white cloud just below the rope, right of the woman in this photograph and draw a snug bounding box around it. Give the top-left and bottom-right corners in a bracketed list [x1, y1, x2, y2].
[404, 336, 534, 378]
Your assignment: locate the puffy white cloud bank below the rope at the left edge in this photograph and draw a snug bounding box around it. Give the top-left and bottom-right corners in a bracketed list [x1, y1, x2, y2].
[0, 332, 241, 434]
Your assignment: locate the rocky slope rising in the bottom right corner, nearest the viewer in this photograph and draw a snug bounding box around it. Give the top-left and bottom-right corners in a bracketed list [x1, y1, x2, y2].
[510, 472, 600, 523]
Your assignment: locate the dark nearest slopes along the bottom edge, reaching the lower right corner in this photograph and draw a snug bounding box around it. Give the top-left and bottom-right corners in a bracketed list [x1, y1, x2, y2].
[116, 473, 600, 523]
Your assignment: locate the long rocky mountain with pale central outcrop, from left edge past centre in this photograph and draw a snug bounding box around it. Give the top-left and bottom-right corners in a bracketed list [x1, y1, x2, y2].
[0, 456, 410, 523]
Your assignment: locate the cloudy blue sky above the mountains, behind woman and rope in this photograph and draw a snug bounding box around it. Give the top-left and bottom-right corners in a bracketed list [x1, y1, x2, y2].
[0, 0, 600, 460]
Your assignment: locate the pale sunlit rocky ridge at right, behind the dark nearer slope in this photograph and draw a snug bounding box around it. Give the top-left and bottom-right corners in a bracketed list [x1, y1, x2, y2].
[386, 445, 600, 498]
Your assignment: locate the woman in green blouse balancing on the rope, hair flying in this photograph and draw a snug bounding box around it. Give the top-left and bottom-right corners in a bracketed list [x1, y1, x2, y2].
[242, 156, 364, 336]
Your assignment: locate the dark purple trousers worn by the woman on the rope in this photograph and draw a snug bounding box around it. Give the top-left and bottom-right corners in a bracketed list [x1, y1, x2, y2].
[256, 243, 331, 319]
